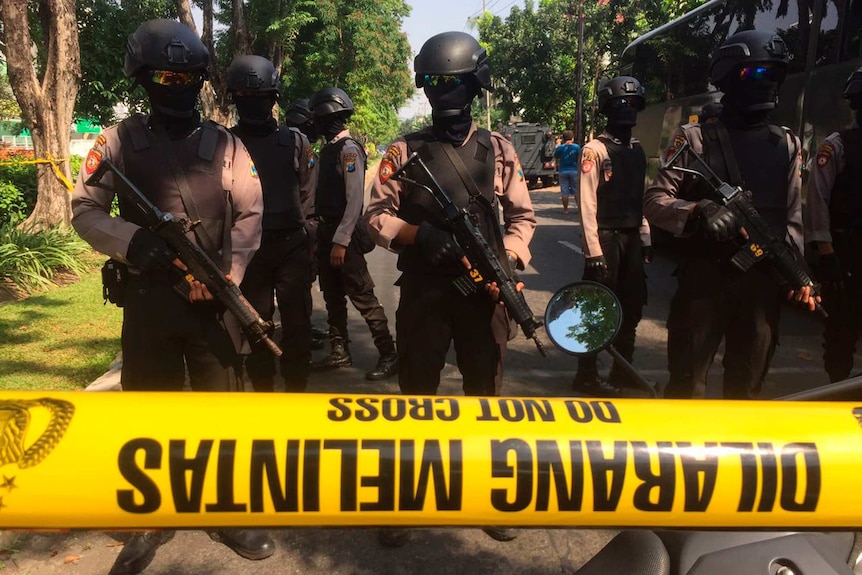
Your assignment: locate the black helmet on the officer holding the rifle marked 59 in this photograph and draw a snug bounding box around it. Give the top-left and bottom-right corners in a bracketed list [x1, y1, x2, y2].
[709, 30, 790, 87]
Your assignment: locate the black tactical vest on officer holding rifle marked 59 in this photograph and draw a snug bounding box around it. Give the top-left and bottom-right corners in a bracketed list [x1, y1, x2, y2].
[696, 122, 795, 257]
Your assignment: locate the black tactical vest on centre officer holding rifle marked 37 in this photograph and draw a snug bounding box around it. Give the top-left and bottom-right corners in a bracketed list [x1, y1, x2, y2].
[398, 128, 505, 276]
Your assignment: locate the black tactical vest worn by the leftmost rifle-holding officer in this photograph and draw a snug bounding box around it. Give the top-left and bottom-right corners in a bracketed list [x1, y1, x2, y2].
[118, 115, 230, 269]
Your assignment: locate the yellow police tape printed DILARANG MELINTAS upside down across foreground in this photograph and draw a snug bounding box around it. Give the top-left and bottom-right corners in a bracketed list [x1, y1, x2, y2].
[0, 392, 862, 529]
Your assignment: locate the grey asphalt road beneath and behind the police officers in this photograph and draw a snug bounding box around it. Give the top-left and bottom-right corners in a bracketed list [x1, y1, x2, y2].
[0, 184, 862, 575]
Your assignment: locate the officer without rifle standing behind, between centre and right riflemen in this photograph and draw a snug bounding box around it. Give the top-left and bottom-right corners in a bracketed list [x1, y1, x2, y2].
[572, 76, 652, 397]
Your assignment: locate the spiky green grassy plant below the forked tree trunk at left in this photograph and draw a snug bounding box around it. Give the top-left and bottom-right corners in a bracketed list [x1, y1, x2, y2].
[0, 222, 88, 292]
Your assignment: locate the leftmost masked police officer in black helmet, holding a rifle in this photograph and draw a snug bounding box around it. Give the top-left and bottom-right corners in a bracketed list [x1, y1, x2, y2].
[72, 20, 275, 575]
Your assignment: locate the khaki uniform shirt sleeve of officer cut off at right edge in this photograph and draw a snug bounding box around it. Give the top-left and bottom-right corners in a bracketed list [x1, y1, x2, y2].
[805, 132, 855, 244]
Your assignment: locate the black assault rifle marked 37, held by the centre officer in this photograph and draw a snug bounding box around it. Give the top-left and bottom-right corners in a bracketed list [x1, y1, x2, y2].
[389, 152, 548, 357]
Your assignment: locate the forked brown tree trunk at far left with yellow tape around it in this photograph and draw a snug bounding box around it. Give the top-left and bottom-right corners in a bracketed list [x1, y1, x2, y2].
[0, 0, 81, 229]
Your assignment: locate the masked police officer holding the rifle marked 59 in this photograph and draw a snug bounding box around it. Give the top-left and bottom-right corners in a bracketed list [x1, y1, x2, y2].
[644, 30, 815, 399]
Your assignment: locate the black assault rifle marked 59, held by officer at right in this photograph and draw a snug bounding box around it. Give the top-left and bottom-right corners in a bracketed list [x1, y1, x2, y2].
[662, 141, 827, 317]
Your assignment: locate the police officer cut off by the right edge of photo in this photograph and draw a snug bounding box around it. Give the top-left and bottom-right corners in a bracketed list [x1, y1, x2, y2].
[805, 68, 862, 382]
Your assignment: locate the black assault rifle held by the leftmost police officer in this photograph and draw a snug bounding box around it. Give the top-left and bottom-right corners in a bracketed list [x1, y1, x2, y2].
[87, 158, 282, 357]
